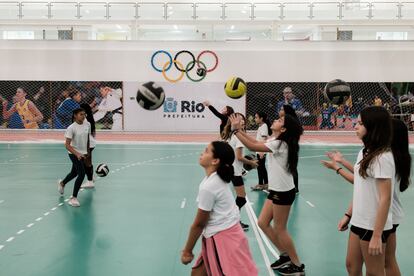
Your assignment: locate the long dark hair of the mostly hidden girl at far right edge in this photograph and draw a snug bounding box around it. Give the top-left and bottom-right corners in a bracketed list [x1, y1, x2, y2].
[391, 119, 411, 192]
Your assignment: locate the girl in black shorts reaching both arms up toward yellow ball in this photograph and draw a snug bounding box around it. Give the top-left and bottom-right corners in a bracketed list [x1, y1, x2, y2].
[230, 114, 305, 275]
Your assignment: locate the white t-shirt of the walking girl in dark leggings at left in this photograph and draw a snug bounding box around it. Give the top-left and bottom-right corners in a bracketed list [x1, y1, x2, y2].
[65, 122, 91, 154]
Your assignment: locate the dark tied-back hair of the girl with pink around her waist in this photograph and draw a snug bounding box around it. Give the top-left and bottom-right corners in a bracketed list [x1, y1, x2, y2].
[211, 141, 235, 183]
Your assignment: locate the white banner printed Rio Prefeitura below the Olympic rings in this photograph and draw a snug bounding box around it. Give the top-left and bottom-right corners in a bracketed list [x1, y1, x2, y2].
[123, 82, 246, 132]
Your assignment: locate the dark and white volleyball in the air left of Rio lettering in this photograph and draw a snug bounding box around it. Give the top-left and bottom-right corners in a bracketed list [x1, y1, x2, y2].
[136, 81, 165, 110]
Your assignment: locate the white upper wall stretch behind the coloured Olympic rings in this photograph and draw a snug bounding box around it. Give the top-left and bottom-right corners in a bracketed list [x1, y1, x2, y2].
[0, 41, 414, 82]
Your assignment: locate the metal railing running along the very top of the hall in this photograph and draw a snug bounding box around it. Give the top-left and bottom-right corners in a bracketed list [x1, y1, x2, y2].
[0, 2, 414, 21]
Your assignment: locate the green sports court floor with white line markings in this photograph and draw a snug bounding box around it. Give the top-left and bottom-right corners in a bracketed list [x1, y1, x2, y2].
[0, 144, 414, 276]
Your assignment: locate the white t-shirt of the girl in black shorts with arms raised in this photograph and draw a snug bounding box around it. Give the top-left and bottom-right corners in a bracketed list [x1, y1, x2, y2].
[265, 138, 295, 192]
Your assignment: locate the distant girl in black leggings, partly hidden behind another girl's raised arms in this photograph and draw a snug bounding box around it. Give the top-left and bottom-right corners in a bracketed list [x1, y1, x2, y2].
[252, 112, 272, 191]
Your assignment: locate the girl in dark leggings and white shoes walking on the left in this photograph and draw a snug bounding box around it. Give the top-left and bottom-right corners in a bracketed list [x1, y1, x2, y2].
[58, 108, 91, 207]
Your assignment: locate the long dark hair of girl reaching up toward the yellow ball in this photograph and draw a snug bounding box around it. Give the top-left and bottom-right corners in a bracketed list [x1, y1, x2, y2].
[277, 114, 303, 173]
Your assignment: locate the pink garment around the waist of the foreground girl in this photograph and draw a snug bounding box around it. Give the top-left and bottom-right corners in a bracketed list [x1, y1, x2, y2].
[193, 223, 258, 276]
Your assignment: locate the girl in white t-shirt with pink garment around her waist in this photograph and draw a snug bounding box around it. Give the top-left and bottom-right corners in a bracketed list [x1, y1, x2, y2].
[181, 141, 258, 276]
